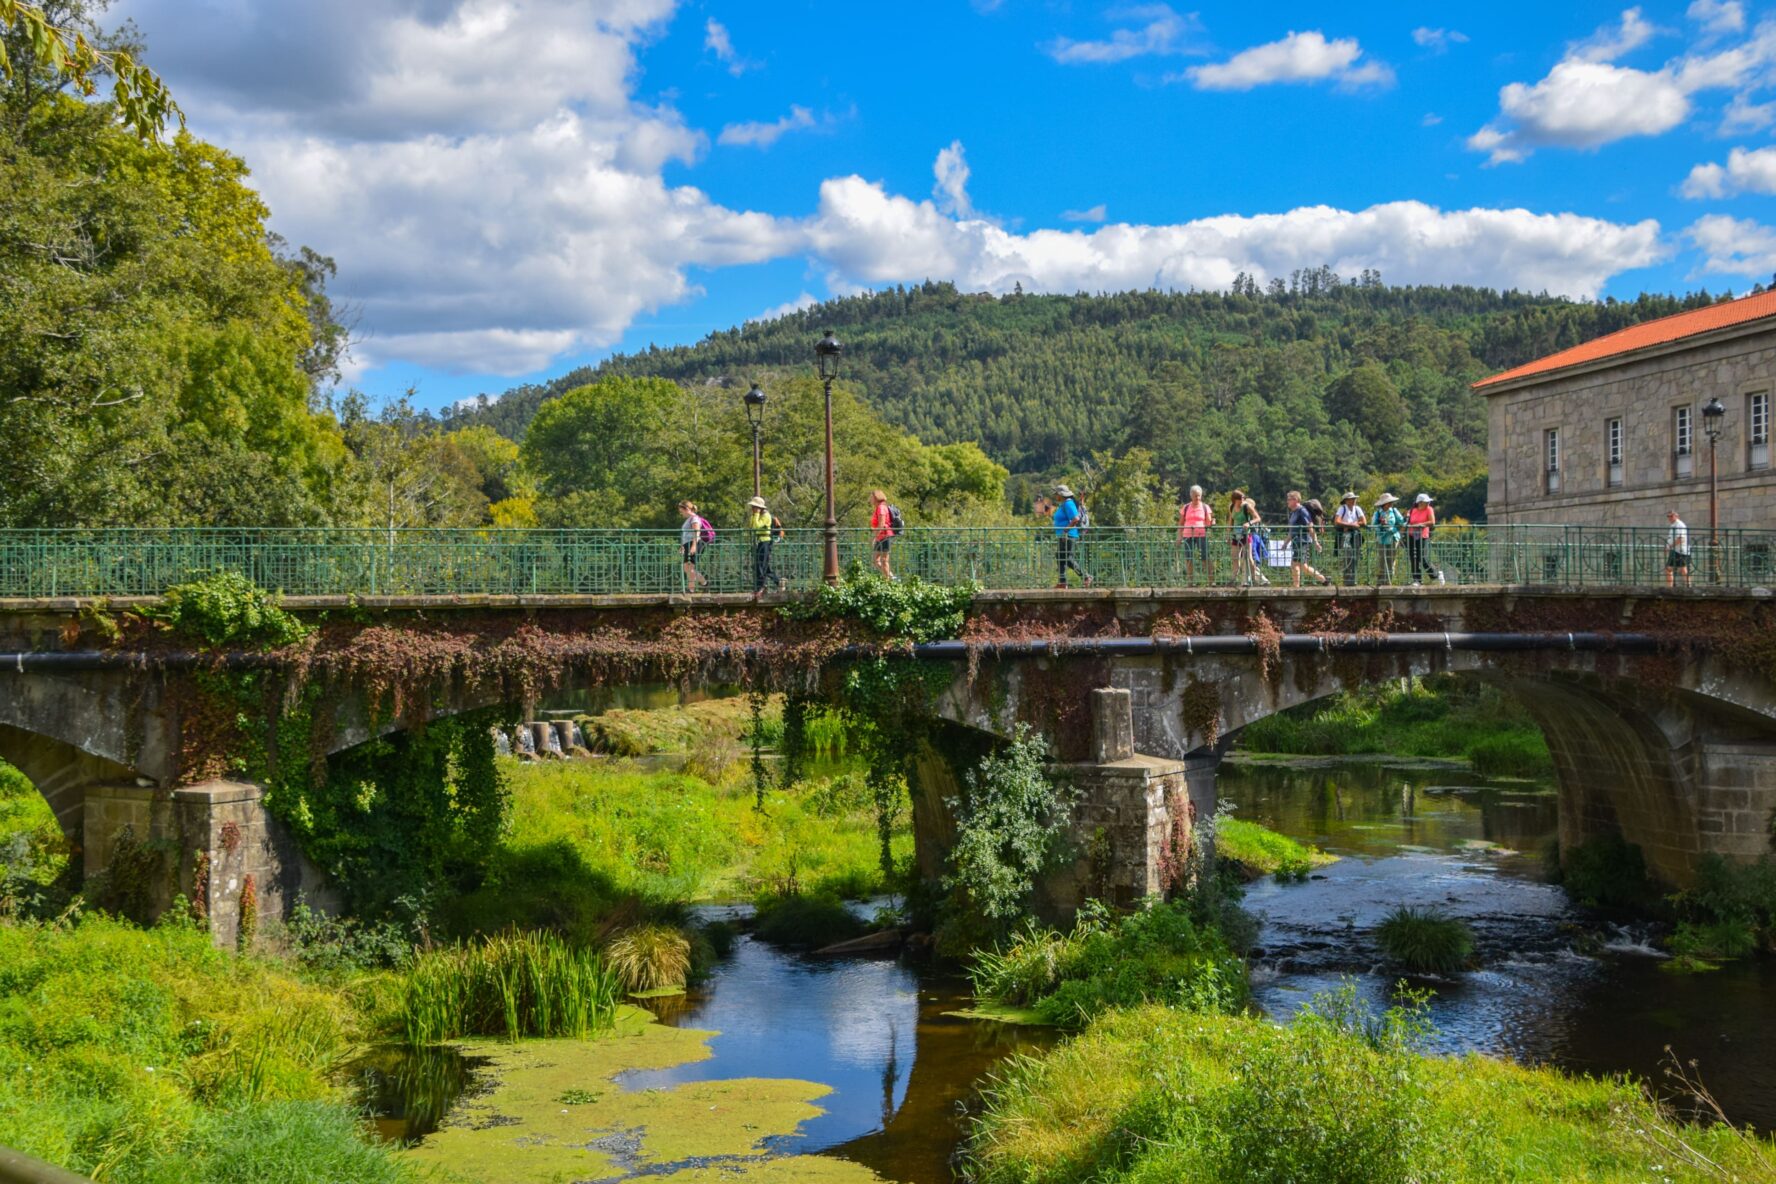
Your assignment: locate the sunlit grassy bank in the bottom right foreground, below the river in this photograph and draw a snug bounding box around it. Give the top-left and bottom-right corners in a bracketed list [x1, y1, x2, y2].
[968, 1005, 1776, 1184]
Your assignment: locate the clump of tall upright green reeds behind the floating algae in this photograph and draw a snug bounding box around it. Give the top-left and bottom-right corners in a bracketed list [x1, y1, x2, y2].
[401, 932, 622, 1047]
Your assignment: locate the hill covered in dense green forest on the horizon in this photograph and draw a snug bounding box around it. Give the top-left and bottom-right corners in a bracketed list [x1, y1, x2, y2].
[453, 280, 1714, 514]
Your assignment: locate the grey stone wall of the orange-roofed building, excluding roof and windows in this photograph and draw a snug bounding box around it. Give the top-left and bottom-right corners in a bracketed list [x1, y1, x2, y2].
[1487, 327, 1776, 528]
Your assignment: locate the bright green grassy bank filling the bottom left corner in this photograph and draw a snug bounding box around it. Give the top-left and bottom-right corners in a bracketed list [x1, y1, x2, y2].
[0, 916, 410, 1184]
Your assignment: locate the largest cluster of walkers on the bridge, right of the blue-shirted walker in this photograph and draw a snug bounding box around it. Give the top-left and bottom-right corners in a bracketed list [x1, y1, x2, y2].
[1165, 485, 1444, 588]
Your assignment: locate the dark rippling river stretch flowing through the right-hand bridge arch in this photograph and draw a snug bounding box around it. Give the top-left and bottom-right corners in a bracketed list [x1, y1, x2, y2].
[1218, 762, 1776, 1129]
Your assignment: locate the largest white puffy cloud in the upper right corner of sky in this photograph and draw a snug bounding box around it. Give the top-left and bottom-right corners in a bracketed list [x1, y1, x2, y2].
[1467, 9, 1776, 165]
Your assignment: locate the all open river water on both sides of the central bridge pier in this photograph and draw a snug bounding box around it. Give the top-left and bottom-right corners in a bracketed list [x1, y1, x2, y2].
[378, 762, 1776, 1184]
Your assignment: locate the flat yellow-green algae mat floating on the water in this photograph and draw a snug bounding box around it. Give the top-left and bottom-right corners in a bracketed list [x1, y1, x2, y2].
[407, 1006, 879, 1184]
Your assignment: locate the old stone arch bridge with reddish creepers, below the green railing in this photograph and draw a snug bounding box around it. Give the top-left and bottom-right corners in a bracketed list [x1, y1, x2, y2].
[0, 588, 1776, 939]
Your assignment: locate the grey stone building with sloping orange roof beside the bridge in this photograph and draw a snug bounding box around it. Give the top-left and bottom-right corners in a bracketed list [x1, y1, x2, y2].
[1474, 291, 1776, 531]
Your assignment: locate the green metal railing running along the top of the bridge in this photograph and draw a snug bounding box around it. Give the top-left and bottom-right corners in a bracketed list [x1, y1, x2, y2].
[0, 525, 1776, 596]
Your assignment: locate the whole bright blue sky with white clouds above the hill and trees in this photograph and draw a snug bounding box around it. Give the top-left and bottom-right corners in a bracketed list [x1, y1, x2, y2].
[115, 0, 1776, 407]
